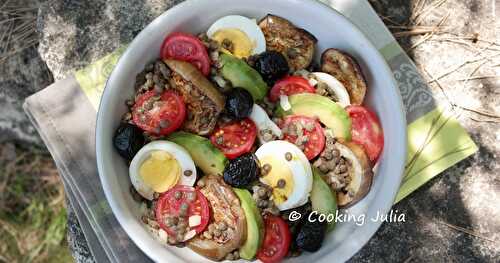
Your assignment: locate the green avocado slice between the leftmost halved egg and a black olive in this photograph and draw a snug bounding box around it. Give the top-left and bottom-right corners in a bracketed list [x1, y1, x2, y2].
[167, 132, 227, 175]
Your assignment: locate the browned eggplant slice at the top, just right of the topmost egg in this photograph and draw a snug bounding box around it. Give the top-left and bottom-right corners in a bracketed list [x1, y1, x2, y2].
[259, 14, 317, 71]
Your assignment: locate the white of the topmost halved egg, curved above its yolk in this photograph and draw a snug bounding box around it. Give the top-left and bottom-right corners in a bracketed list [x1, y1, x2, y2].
[207, 15, 266, 55]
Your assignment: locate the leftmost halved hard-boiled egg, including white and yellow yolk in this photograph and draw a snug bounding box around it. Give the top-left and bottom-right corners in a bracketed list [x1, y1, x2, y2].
[129, 141, 196, 200]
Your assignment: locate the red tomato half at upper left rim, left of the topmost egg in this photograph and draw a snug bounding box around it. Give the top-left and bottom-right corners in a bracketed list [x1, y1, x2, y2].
[161, 32, 210, 76]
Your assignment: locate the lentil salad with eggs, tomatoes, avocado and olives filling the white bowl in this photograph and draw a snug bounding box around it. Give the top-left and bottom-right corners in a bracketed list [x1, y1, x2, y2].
[114, 15, 383, 262]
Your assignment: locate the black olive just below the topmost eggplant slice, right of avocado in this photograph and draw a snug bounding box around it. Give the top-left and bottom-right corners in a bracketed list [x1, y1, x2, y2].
[255, 51, 290, 85]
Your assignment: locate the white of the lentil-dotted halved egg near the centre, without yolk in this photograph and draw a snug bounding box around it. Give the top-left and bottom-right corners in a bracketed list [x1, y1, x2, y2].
[255, 141, 313, 211]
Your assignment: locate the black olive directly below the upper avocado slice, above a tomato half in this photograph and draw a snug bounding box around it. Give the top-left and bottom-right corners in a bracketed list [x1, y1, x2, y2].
[226, 88, 253, 120]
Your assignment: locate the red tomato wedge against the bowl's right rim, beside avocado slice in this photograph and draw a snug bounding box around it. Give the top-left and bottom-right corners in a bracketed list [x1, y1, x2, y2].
[346, 105, 384, 163]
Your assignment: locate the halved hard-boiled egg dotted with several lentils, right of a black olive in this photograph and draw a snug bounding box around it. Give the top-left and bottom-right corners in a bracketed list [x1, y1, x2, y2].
[255, 141, 312, 210]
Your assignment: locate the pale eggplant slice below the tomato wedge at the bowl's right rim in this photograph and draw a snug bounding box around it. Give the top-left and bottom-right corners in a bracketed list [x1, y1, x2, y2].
[335, 142, 373, 208]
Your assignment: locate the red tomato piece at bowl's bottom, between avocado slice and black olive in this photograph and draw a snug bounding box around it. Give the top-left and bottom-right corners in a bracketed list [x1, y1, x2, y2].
[257, 215, 292, 263]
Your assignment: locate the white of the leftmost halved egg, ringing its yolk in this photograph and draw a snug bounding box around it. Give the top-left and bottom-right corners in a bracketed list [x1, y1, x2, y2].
[129, 141, 196, 200]
